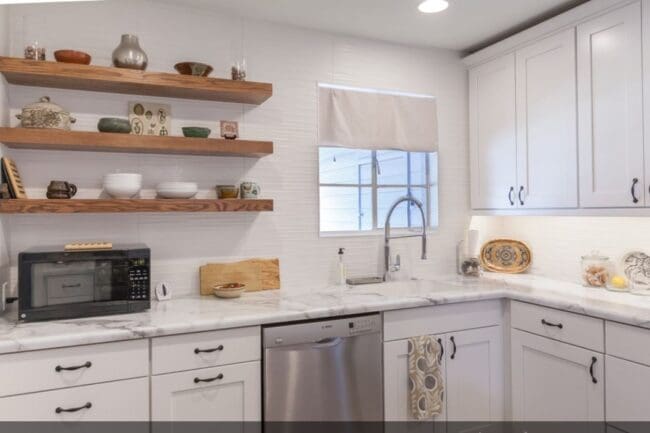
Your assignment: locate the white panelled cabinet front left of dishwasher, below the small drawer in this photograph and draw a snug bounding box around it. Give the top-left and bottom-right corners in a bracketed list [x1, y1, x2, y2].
[151, 361, 262, 424]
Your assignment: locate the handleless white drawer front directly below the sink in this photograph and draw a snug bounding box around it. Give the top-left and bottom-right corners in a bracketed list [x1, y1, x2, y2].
[384, 300, 503, 341]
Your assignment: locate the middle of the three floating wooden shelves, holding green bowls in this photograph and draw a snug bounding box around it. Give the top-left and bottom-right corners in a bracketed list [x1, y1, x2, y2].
[0, 128, 273, 158]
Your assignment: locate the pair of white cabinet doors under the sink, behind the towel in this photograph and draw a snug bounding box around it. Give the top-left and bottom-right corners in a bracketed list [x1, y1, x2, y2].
[384, 326, 504, 431]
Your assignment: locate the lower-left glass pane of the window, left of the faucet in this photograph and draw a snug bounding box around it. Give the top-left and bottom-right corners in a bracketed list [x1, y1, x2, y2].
[320, 186, 372, 232]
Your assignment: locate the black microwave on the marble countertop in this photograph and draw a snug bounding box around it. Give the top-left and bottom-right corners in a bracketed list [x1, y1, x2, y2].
[18, 245, 151, 322]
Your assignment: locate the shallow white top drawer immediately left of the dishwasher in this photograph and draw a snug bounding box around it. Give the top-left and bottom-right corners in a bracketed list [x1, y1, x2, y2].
[151, 327, 261, 374]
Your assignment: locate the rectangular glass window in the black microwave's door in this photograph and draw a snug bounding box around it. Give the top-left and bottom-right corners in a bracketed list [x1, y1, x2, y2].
[32, 262, 95, 308]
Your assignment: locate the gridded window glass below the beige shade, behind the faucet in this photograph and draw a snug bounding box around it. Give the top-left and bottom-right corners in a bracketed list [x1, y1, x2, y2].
[319, 147, 438, 233]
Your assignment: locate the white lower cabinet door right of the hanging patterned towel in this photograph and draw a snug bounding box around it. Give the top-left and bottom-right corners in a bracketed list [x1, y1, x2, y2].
[445, 326, 504, 422]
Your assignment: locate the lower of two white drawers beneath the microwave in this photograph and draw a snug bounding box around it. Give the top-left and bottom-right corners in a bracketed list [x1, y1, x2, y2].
[0, 378, 149, 420]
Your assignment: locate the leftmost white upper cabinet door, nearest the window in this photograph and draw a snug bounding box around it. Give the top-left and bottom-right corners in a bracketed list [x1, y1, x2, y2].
[469, 54, 517, 209]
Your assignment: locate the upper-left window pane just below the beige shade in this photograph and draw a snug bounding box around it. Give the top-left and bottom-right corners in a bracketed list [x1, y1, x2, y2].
[319, 147, 372, 185]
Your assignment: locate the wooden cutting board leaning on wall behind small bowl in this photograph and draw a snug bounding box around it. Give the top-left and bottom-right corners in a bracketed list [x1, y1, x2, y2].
[200, 259, 280, 296]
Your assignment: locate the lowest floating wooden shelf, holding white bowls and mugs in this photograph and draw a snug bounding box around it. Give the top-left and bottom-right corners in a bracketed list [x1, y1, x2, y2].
[0, 199, 273, 214]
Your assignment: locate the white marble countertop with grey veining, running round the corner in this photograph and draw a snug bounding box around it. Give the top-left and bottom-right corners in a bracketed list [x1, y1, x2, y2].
[0, 274, 650, 354]
